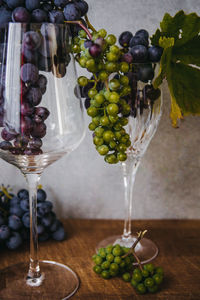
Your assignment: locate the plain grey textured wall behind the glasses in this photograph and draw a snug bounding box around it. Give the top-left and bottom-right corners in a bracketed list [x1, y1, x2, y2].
[0, 0, 200, 218]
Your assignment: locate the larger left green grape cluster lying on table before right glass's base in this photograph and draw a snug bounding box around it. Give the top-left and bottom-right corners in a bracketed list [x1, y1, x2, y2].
[92, 244, 134, 281]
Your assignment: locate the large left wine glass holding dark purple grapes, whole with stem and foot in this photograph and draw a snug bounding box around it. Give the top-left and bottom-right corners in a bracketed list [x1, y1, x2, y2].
[0, 23, 84, 299]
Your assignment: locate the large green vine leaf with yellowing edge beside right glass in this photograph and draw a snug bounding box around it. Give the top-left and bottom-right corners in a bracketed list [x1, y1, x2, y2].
[151, 11, 200, 127]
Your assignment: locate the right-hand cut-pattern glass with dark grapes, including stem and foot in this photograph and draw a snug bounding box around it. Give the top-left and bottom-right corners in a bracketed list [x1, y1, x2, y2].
[97, 63, 162, 265]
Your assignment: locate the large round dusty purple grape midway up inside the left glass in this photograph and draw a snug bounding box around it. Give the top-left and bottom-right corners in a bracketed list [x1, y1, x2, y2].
[21, 63, 39, 84]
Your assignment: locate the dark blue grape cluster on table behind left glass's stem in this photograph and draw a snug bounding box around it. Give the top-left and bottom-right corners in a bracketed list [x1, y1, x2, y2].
[0, 187, 65, 250]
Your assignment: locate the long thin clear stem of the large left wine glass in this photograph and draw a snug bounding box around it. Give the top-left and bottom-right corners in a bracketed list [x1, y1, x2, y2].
[25, 174, 41, 285]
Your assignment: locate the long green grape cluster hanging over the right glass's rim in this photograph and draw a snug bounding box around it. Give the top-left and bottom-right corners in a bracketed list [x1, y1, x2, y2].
[72, 29, 131, 164]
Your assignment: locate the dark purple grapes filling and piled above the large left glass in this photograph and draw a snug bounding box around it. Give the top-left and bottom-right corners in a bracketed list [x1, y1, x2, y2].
[0, 0, 88, 155]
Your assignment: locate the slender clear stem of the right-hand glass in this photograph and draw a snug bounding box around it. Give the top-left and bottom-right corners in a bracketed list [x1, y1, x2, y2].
[122, 154, 140, 239]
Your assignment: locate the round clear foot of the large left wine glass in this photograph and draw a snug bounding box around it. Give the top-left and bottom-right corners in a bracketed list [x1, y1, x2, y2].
[0, 260, 79, 300]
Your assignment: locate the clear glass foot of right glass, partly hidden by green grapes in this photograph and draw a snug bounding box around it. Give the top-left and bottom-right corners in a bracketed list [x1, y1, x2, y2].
[96, 235, 158, 265]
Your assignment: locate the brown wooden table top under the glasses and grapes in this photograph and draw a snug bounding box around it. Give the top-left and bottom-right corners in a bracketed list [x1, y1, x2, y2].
[0, 219, 200, 300]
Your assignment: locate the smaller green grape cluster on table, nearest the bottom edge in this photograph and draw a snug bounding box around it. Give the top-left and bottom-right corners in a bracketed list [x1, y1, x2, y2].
[131, 264, 163, 294]
